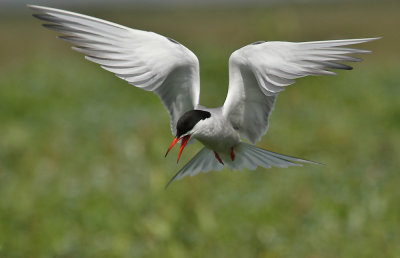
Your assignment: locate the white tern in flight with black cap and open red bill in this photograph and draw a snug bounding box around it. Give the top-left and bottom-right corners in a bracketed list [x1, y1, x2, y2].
[28, 5, 378, 185]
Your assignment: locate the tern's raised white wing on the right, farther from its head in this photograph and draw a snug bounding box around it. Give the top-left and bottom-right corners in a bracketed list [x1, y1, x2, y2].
[223, 38, 378, 143]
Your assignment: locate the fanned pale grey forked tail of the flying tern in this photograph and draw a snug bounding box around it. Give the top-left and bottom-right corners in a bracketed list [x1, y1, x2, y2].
[166, 142, 322, 187]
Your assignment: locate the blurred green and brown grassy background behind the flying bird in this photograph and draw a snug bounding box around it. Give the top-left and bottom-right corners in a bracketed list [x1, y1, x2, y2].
[0, 1, 400, 257]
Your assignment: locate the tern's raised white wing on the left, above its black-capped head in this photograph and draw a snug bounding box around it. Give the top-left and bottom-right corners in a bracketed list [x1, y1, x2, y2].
[28, 5, 200, 135]
